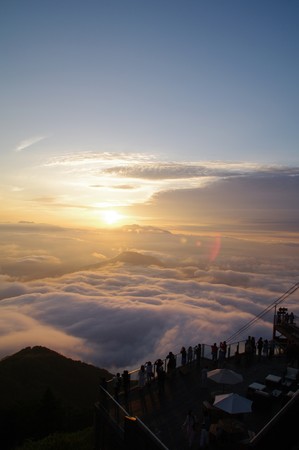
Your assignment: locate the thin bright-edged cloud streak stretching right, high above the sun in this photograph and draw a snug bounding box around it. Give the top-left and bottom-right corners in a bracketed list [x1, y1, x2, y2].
[45, 152, 299, 187]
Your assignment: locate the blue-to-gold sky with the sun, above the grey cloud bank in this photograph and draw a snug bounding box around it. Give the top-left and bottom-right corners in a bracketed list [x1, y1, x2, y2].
[0, 0, 299, 226]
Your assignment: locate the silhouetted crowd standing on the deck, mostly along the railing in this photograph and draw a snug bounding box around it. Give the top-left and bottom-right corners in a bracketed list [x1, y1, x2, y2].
[107, 336, 292, 448]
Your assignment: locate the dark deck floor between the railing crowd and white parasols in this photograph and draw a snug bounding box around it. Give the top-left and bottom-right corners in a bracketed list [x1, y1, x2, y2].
[115, 355, 296, 450]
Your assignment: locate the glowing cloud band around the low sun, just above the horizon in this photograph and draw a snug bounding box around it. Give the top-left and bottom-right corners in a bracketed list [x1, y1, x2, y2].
[1, 151, 299, 231]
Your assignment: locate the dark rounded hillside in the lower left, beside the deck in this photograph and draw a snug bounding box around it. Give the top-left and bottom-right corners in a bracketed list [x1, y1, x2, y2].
[0, 347, 112, 449]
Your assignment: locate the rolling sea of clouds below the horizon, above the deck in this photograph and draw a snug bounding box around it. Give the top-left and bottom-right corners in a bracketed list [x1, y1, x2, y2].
[0, 224, 299, 371]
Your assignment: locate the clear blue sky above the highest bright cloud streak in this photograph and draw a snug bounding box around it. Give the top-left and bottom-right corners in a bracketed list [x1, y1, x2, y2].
[0, 0, 299, 164]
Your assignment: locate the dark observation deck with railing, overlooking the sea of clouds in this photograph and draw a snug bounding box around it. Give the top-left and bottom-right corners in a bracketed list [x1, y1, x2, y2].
[95, 317, 299, 450]
